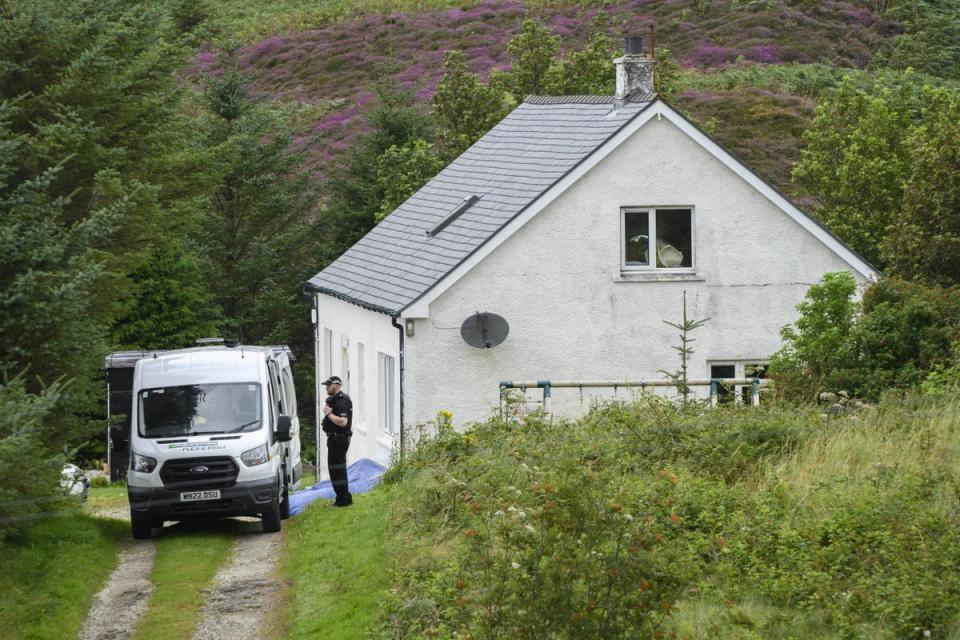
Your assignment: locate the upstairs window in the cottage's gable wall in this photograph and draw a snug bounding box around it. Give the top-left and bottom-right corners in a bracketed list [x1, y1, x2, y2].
[621, 208, 693, 270]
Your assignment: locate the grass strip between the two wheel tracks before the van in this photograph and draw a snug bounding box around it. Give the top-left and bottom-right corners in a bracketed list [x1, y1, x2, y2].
[133, 520, 236, 640]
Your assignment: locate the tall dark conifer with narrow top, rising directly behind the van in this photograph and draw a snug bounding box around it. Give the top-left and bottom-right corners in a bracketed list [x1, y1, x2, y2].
[199, 63, 316, 343]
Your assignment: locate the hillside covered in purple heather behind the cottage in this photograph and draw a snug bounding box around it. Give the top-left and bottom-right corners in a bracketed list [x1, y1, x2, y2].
[196, 0, 901, 191]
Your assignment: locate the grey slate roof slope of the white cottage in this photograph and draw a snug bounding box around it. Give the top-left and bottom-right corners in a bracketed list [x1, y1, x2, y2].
[307, 94, 654, 313]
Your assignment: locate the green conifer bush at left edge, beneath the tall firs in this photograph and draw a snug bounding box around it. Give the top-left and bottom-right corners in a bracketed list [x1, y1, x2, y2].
[0, 376, 64, 548]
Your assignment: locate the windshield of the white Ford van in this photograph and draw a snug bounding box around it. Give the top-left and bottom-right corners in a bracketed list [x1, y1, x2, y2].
[139, 382, 261, 438]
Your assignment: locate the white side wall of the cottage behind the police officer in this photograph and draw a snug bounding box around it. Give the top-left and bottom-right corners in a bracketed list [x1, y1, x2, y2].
[316, 293, 400, 468]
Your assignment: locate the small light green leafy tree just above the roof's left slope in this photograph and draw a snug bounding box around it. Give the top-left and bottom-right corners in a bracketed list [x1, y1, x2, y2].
[377, 138, 445, 222]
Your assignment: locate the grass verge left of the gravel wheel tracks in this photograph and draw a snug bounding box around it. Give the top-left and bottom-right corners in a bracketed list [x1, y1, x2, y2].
[0, 514, 129, 640]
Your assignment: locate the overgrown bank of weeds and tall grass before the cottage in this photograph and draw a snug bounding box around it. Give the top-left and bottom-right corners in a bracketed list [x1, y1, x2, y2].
[377, 397, 960, 638]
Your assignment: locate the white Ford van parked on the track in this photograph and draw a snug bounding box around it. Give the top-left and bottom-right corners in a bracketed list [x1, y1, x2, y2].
[121, 345, 303, 538]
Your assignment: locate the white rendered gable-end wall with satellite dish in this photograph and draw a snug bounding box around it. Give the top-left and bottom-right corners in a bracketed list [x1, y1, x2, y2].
[405, 119, 864, 426]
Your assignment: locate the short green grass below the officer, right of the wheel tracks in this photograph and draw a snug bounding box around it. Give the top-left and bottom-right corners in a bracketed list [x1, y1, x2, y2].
[281, 487, 392, 640]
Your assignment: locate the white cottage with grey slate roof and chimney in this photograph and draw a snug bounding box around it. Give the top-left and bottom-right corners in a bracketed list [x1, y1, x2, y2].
[308, 39, 876, 470]
